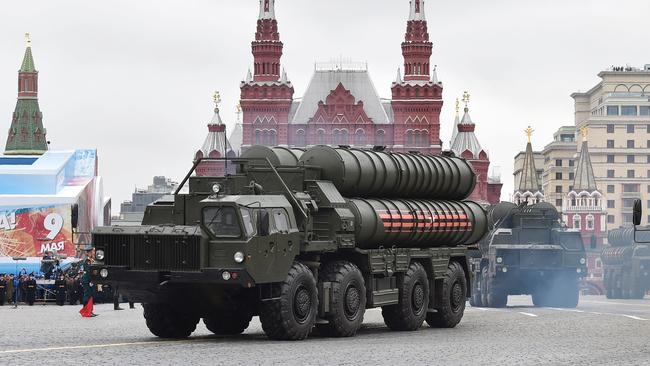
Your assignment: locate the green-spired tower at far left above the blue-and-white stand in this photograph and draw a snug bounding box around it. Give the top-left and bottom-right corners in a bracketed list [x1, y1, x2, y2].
[5, 34, 47, 155]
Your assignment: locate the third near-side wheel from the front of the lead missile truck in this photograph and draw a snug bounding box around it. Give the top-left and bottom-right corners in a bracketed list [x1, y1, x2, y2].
[381, 262, 429, 331]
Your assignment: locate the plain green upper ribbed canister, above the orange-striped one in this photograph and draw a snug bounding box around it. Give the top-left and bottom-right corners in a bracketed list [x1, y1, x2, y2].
[300, 146, 476, 200]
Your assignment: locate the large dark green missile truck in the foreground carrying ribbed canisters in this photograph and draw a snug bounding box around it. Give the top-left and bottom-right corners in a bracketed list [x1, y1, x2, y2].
[92, 146, 487, 340]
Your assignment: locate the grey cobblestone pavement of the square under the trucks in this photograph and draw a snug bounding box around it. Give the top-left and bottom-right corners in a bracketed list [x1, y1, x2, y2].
[0, 296, 650, 366]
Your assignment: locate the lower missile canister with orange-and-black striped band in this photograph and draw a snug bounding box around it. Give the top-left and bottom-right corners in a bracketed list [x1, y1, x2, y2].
[348, 198, 487, 249]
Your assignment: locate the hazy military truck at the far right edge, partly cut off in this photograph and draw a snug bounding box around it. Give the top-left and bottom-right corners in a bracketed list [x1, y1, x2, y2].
[600, 227, 650, 299]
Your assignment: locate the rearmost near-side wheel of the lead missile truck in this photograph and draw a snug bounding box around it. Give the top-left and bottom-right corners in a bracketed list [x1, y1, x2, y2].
[427, 262, 467, 328]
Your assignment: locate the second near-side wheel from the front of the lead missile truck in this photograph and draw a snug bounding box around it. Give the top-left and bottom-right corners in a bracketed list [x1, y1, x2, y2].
[316, 261, 366, 337]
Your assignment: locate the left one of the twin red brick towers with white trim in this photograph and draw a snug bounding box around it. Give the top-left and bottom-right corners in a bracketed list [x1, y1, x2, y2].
[240, 0, 293, 149]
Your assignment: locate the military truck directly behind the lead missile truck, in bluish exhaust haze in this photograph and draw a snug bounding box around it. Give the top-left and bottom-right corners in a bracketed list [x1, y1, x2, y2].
[470, 202, 587, 308]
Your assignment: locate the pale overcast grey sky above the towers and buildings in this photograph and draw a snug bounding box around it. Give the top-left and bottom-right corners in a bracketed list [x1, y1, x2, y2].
[0, 0, 650, 212]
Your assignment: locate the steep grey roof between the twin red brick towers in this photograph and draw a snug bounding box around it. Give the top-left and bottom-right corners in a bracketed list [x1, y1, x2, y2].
[291, 67, 391, 124]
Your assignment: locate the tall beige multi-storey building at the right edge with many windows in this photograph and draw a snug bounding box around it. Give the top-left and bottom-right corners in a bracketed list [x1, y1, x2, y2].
[571, 65, 650, 229]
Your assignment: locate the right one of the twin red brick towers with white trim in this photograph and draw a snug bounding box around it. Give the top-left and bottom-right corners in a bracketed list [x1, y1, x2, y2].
[391, 0, 443, 153]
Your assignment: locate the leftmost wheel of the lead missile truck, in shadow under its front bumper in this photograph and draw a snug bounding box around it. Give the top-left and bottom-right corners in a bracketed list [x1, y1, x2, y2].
[143, 304, 199, 338]
